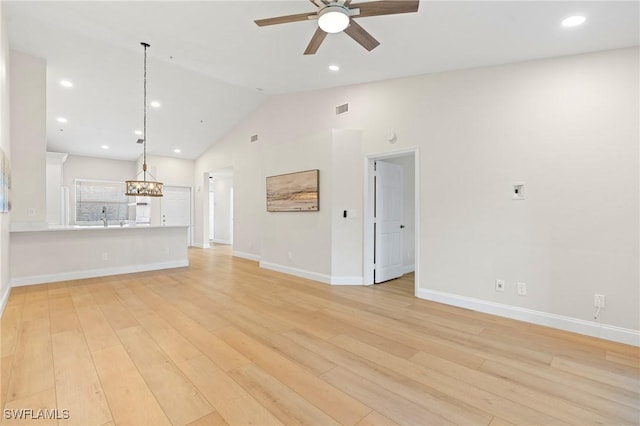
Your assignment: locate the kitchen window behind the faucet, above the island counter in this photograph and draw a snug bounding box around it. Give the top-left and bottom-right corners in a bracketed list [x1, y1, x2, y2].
[76, 179, 130, 225]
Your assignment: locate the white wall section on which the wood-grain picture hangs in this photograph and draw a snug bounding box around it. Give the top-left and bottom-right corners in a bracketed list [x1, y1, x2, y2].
[196, 130, 363, 284]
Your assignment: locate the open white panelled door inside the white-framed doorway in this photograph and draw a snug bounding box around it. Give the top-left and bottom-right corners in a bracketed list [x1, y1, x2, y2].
[374, 161, 404, 283]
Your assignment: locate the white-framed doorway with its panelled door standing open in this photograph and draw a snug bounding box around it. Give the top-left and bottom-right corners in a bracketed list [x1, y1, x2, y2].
[363, 148, 420, 294]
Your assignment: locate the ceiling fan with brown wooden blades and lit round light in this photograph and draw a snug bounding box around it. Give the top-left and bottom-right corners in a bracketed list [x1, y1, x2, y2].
[254, 0, 420, 55]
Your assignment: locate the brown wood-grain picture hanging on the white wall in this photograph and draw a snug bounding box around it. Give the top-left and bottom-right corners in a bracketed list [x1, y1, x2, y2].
[267, 169, 320, 212]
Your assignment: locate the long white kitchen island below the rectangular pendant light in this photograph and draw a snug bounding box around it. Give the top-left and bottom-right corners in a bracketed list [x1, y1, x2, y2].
[9, 225, 189, 286]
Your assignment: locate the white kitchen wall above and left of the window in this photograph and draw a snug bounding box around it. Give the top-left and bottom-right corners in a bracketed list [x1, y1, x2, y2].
[63, 155, 136, 224]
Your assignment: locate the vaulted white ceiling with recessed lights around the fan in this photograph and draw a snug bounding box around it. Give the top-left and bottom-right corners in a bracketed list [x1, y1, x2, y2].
[4, 0, 640, 159]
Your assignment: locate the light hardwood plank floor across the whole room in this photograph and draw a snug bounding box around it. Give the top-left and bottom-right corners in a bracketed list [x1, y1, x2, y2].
[0, 246, 640, 425]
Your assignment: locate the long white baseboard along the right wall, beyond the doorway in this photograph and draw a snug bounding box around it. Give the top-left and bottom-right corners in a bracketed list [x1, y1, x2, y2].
[417, 289, 640, 346]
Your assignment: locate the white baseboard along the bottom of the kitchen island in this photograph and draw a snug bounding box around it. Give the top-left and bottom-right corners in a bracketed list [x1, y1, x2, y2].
[11, 260, 189, 287]
